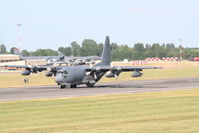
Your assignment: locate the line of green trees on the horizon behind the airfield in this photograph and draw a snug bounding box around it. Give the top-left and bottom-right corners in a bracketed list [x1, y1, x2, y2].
[0, 39, 199, 61]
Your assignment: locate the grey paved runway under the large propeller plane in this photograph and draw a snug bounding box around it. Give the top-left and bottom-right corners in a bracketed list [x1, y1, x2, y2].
[0, 77, 199, 101]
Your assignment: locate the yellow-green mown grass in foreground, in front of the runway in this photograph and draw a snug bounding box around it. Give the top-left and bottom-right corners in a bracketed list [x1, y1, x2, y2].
[0, 89, 199, 133]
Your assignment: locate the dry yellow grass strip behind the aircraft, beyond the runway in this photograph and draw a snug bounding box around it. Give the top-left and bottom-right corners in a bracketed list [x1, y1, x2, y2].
[0, 62, 199, 88]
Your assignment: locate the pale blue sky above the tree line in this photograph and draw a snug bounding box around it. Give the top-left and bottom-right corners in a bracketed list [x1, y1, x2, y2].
[0, 0, 199, 50]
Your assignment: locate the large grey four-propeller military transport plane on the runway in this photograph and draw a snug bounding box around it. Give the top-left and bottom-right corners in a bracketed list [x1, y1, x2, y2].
[5, 36, 159, 89]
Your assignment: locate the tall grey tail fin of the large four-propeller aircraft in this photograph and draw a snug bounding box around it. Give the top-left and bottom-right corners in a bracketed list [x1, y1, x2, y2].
[97, 36, 111, 65]
